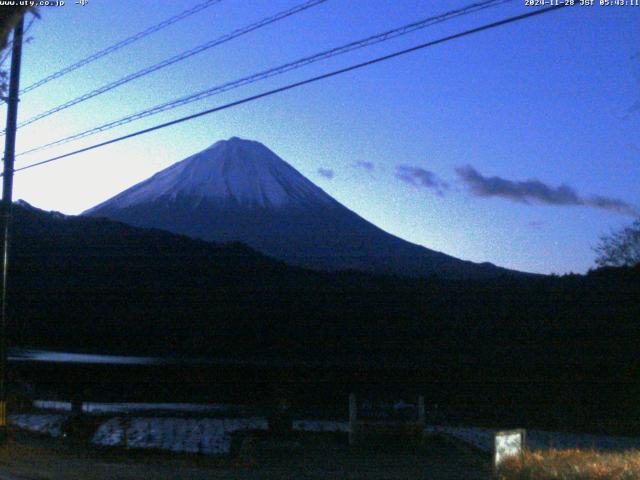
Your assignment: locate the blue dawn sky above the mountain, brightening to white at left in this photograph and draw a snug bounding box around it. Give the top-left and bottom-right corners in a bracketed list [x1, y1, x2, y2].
[0, 0, 640, 273]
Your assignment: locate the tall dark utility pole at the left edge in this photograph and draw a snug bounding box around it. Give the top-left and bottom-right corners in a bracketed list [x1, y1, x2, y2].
[0, 15, 24, 443]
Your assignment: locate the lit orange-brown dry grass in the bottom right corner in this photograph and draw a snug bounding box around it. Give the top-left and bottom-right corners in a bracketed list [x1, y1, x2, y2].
[495, 450, 640, 480]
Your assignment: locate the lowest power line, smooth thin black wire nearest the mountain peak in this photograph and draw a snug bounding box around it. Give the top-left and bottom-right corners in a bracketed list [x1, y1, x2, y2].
[15, 4, 567, 172]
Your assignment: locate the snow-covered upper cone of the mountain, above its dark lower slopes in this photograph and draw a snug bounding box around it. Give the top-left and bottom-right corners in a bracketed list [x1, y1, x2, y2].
[95, 137, 336, 213]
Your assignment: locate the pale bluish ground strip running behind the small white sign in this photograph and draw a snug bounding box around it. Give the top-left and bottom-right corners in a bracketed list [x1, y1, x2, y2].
[425, 426, 640, 452]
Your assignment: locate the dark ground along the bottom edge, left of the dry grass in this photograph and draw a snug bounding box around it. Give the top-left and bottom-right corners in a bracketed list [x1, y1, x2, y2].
[0, 432, 490, 480]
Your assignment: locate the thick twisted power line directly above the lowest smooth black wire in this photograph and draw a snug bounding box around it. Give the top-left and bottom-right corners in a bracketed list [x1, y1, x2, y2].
[19, 0, 512, 156]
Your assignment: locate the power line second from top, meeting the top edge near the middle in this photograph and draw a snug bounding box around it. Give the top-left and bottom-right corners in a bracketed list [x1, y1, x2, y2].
[9, 0, 327, 133]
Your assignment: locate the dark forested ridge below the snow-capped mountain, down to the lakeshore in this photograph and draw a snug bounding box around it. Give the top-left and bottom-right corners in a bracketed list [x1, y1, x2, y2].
[9, 200, 640, 380]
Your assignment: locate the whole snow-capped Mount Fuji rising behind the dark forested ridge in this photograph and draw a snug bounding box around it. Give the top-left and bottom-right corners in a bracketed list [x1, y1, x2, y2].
[83, 137, 516, 278]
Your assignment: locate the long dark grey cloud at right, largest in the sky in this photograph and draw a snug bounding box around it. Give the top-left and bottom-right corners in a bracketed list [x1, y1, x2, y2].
[456, 165, 640, 216]
